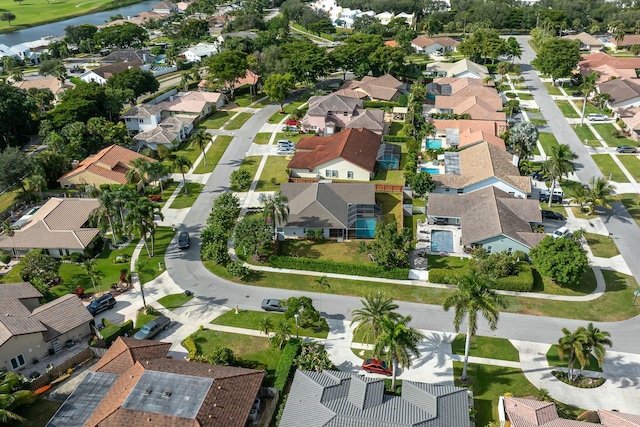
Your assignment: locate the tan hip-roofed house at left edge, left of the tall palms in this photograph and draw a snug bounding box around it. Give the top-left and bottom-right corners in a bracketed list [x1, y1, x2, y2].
[0, 197, 100, 258]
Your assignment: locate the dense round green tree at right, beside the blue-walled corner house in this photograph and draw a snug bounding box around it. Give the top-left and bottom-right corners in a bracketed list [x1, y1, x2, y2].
[529, 236, 589, 285]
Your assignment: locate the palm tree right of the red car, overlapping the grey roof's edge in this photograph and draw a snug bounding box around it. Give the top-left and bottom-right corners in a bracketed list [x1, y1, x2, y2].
[373, 316, 424, 391]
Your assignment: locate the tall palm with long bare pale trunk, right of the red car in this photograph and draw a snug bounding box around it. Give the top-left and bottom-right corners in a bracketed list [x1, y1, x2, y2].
[443, 270, 506, 381]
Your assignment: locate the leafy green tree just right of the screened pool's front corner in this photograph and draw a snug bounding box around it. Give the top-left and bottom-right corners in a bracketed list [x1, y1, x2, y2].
[368, 221, 415, 268]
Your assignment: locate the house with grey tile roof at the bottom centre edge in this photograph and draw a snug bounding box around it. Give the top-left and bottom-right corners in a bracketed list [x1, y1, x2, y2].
[280, 370, 469, 427]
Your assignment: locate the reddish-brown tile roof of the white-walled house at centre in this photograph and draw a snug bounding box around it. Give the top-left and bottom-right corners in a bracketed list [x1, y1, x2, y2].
[287, 129, 382, 172]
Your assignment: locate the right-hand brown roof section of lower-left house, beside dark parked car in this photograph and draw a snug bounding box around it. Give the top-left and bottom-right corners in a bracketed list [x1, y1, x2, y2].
[31, 294, 93, 341]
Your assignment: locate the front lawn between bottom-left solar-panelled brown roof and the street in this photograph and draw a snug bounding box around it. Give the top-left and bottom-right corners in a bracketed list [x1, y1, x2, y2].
[182, 329, 282, 386]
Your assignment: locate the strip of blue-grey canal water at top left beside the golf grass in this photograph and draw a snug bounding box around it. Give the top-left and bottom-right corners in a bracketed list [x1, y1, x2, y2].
[0, 0, 158, 46]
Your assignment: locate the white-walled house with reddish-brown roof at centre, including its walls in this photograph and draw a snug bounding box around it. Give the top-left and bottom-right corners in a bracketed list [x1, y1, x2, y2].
[287, 129, 382, 181]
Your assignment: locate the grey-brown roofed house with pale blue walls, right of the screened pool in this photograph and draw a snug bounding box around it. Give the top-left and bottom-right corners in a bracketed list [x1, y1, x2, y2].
[427, 186, 546, 253]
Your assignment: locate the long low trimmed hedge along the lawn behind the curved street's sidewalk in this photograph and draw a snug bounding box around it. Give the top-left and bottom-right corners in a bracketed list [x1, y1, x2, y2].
[269, 255, 409, 280]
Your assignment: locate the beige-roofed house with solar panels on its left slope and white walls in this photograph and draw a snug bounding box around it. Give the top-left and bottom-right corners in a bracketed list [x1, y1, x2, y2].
[429, 142, 531, 198]
